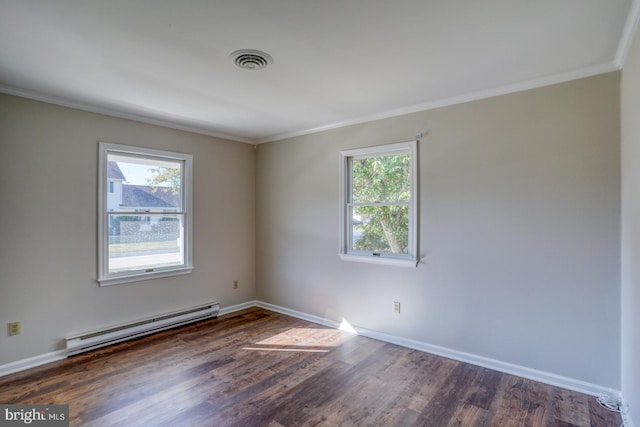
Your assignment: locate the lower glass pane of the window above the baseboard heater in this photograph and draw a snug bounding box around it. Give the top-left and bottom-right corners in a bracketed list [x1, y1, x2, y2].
[108, 214, 185, 273]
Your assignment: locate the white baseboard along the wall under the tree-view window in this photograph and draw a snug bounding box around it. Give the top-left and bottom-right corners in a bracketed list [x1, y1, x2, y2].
[256, 301, 620, 396]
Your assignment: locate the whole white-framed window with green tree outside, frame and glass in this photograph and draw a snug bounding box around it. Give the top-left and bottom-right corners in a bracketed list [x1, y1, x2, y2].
[340, 141, 418, 266]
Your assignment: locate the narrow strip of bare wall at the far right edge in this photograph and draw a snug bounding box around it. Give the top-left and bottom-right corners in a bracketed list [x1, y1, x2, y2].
[621, 24, 640, 423]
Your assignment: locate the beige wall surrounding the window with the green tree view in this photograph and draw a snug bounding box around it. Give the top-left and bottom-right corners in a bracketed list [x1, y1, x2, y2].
[256, 73, 620, 389]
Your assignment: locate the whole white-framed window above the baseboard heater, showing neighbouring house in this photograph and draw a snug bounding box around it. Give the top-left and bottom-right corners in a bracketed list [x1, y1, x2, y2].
[98, 142, 193, 286]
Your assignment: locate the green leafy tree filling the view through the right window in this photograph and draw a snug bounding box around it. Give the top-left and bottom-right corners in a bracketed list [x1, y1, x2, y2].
[352, 154, 411, 253]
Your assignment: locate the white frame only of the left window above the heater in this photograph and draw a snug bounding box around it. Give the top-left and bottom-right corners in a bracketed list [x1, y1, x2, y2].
[97, 142, 193, 286]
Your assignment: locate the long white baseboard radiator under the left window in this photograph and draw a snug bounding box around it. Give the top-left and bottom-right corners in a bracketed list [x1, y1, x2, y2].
[66, 302, 220, 356]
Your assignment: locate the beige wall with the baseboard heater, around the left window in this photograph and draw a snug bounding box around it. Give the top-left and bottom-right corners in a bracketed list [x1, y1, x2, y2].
[0, 94, 255, 365]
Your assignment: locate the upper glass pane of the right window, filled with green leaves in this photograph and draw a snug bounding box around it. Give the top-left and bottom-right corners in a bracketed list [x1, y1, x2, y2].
[351, 154, 411, 203]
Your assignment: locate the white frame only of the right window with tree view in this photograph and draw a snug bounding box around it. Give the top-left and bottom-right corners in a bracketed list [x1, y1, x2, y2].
[338, 141, 419, 267]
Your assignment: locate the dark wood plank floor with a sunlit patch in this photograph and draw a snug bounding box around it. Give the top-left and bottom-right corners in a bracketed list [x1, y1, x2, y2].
[0, 308, 621, 427]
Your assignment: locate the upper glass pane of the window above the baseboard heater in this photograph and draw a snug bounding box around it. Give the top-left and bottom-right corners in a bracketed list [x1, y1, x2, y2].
[106, 154, 183, 212]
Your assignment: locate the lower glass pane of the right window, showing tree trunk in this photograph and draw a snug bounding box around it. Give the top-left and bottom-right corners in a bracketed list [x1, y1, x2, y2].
[350, 205, 409, 254]
